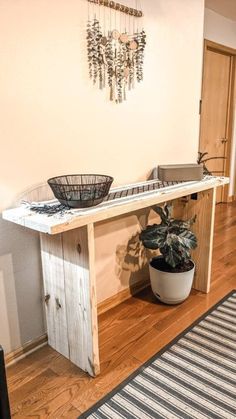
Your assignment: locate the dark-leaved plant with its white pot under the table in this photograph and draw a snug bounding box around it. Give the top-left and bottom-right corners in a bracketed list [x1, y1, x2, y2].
[140, 204, 197, 304]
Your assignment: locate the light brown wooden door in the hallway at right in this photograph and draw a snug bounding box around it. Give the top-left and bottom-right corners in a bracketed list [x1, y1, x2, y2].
[199, 44, 234, 202]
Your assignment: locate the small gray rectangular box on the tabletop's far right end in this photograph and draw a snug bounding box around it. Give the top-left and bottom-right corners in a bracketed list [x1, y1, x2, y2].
[158, 164, 203, 182]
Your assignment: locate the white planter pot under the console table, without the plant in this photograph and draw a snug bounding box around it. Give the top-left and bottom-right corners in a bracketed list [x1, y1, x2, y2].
[149, 261, 195, 304]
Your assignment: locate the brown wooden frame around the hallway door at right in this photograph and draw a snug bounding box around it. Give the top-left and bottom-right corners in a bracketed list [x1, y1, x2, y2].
[199, 39, 236, 202]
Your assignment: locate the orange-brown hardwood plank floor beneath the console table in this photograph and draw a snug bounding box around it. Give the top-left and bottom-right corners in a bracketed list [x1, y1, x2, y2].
[7, 203, 236, 419]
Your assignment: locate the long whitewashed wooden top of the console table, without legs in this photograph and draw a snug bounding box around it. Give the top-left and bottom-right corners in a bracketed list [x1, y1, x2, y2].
[2, 176, 229, 234]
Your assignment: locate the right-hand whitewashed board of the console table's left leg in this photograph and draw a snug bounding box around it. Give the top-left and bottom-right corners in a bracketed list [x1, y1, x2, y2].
[63, 225, 100, 376]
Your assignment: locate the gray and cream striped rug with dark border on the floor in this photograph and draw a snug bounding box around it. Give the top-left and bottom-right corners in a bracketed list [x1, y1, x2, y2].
[80, 290, 236, 419]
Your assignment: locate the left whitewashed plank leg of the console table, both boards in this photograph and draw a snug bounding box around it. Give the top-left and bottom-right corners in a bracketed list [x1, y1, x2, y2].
[41, 224, 100, 376]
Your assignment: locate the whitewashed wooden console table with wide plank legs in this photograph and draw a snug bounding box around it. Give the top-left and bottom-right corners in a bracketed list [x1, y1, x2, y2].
[3, 177, 229, 376]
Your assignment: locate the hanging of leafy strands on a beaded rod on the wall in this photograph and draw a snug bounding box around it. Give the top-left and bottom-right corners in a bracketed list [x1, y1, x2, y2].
[87, 0, 146, 103]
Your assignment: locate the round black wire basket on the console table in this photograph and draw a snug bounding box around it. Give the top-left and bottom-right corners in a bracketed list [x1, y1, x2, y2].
[48, 175, 114, 208]
